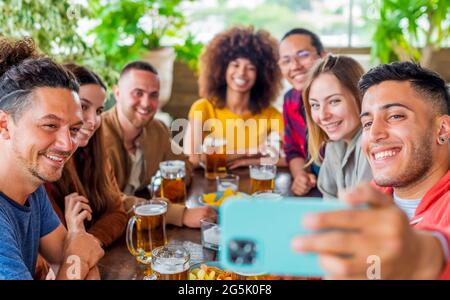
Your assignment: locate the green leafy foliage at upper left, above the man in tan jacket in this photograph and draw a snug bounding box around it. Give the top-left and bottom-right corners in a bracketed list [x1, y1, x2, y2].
[0, 0, 202, 86]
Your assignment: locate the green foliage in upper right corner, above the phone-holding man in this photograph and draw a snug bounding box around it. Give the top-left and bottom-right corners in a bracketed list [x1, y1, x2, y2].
[372, 0, 450, 65]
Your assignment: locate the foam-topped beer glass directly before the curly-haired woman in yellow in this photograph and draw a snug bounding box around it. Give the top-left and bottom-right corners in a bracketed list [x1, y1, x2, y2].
[203, 137, 227, 179]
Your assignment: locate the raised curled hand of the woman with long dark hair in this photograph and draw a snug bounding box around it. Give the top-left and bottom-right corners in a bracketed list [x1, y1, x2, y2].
[64, 193, 92, 232]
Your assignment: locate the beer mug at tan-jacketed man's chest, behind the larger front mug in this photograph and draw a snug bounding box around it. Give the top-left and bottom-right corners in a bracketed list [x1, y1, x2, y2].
[159, 160, 186, 204]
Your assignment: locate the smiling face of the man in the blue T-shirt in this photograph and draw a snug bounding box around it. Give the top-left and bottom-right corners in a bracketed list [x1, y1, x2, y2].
[9, 87, 83, 183]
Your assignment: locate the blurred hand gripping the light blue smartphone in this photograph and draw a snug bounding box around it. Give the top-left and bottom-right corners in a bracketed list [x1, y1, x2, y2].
[292, 184, 445, 279]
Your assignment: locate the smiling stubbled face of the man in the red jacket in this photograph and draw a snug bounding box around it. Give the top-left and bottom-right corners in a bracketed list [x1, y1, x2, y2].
[361, 81, 439, 187]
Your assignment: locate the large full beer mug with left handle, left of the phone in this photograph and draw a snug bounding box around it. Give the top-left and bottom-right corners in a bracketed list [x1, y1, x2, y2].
[126, 199, 167, 265]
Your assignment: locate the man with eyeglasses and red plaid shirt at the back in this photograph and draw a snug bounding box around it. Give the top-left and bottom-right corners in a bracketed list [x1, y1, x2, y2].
[278, 28, 326, 196]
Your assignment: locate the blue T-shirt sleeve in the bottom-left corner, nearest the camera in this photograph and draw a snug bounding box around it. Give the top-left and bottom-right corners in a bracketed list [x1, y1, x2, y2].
[0, 210, 33, 280]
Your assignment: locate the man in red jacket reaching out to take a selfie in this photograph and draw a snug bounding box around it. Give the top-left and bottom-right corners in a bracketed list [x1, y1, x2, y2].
[292, 62, 450, 279]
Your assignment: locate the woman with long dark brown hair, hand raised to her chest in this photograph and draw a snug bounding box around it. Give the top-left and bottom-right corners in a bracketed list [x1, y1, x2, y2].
[46, 64, 127, 247]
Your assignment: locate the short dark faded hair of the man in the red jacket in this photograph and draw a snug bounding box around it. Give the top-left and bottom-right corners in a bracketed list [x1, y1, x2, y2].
[358, 62, 450, 115]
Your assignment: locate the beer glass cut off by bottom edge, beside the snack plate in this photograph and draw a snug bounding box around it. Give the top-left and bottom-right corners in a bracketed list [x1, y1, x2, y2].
[152, 246, 191, 280]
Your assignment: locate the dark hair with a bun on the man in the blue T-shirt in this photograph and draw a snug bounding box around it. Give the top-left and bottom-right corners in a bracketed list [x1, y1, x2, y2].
[0, 38, 79, 122]
